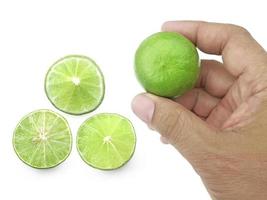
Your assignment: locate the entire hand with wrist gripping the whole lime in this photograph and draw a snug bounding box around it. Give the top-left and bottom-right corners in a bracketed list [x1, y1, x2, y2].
[132, 21, 267, 200]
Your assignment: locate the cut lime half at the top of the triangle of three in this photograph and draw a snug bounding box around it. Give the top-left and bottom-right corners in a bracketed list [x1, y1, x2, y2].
[45, 55, 104, 115]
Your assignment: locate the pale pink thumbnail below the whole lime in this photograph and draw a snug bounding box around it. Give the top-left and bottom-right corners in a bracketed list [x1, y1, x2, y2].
[132, 94, 155, 124]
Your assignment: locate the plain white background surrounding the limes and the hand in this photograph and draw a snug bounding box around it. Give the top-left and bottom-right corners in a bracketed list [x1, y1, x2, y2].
[0, 0, 267, 200]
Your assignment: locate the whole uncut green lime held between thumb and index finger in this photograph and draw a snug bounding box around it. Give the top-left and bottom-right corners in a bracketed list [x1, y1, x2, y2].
[135, 32, 200, 97]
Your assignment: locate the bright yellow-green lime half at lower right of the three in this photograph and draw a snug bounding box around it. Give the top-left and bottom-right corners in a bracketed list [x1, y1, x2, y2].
[77, 113, 136, 170]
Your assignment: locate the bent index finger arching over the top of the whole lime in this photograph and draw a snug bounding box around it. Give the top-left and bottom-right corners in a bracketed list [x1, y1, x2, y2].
[162, 21, 266, 76]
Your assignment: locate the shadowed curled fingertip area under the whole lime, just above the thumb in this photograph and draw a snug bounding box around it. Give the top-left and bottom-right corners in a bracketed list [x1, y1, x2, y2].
[174, 88, 220, 118]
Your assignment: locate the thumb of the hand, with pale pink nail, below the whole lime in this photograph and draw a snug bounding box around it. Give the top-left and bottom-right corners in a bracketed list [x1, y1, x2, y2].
[132, 94, 214, 157]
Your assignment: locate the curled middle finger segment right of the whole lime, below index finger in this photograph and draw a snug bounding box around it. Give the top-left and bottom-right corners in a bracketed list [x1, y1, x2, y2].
[197, 60, 235, 97]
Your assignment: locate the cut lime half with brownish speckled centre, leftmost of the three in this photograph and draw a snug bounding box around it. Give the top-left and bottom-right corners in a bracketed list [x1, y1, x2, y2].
[13, 110, 72, 168]
